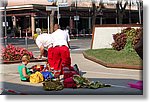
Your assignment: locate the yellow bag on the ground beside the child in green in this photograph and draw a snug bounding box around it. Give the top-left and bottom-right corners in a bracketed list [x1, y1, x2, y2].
[30, 72, 44, 83]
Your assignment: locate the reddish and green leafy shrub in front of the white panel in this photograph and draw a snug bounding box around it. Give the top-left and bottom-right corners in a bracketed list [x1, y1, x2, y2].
[111, 28, 143, 52]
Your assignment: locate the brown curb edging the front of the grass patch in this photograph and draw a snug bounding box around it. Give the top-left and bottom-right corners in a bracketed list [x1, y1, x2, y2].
[83, 52, 143, 70]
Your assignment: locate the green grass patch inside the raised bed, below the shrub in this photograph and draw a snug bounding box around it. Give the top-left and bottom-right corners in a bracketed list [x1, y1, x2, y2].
[85, 48, 142, 65]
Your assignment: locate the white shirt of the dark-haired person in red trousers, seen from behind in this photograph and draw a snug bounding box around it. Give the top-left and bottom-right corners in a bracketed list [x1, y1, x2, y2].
[52, 29, 70, 47]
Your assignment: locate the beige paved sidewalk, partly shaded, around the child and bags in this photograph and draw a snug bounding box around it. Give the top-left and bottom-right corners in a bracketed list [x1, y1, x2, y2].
[0, 53, 142, 95]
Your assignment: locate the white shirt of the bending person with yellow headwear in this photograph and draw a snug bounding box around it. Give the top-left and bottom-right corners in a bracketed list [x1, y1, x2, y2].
[36, 33, 53, 48]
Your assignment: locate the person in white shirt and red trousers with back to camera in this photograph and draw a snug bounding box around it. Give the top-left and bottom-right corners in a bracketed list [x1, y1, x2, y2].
[52, 24, 71, 78]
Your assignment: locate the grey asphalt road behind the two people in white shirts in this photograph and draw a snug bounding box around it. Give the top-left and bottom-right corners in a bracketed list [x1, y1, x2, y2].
[1, 37, 92, 52]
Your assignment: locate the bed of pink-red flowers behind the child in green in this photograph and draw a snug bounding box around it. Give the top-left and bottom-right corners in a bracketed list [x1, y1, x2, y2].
[1, 44, 47, 64]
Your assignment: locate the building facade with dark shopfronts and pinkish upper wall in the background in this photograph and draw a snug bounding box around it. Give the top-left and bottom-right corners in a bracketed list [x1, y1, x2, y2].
[0, 0, 143, 36]
